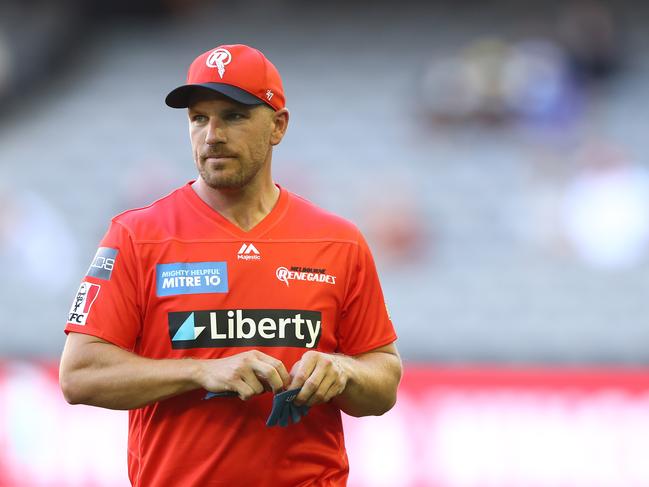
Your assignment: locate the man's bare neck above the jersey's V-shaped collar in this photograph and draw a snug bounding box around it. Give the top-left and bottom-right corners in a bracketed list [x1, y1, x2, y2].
[192, 177, 280, 232]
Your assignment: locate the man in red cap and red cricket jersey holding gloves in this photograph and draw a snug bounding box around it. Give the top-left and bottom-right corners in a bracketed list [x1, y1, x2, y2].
[60, 45, 401, 487]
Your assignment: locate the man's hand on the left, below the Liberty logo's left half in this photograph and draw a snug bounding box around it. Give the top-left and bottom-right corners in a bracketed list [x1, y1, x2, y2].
[199, 350, 291, 401]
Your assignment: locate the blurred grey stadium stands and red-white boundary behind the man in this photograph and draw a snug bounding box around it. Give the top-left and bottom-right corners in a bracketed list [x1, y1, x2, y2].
[0, 0, 649, 487]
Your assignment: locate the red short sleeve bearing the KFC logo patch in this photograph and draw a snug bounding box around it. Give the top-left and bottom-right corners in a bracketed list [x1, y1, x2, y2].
[65, 220, 142, 350]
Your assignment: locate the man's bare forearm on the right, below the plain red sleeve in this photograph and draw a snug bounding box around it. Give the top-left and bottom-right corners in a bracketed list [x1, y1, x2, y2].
[334, 351, 401, 417]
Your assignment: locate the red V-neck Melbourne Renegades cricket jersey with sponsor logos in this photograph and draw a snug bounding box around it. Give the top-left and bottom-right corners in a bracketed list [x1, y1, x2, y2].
[65, 183, 396, 487]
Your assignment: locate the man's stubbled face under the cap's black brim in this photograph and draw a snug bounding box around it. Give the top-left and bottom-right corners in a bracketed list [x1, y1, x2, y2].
[189, 91, 283, 189]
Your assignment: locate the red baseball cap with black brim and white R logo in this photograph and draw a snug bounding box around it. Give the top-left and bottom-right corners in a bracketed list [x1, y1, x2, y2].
[165, 44, 286, 110]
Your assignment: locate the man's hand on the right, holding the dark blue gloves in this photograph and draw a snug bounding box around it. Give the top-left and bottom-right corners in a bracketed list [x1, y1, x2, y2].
[288, 350, 349, 407]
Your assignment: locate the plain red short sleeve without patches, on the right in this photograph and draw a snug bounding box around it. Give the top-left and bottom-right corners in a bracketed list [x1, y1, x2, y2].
[337, 232, 397, 355]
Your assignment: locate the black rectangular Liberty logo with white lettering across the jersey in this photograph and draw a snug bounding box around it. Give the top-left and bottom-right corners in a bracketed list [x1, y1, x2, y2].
[168, 309, 322, 349]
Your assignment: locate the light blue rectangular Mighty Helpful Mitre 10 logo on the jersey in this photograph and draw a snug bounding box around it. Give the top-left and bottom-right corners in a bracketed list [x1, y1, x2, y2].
[155, 262, 228, 296]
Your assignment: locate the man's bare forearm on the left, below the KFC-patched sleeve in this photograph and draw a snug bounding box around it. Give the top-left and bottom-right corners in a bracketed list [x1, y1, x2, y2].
[60, 341, 200, 409]
